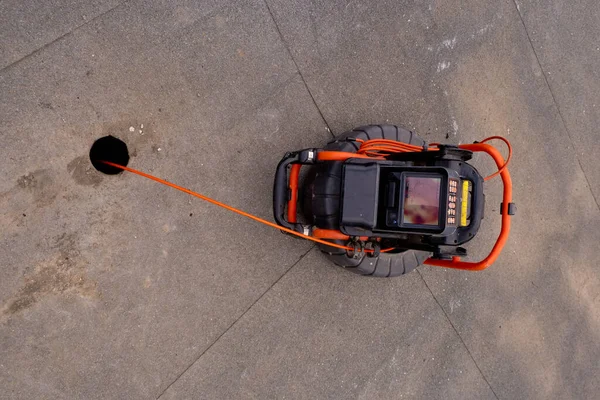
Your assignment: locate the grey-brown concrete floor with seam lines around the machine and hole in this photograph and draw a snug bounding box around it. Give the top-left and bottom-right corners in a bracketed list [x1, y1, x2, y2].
[0, 0, 600, 399]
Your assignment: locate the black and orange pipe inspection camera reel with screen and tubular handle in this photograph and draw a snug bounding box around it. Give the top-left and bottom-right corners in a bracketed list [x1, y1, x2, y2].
[273, 125, 516, 277]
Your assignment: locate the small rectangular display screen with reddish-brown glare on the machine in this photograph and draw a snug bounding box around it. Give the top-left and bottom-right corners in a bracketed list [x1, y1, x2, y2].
[403, 176, 442, 226]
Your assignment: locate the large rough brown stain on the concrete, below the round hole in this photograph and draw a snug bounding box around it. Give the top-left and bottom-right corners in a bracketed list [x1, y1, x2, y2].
[0, 233, 98, 320]
